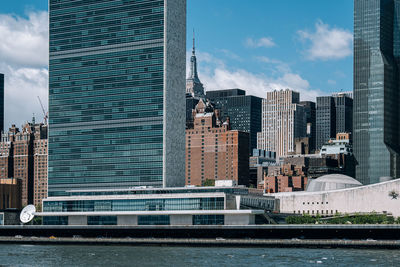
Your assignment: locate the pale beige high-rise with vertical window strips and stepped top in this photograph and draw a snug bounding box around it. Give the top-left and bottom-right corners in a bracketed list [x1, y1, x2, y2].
[257, 89, 307, 159]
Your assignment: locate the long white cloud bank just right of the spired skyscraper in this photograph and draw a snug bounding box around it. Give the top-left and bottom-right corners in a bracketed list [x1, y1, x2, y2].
[187, 50, 322, 101]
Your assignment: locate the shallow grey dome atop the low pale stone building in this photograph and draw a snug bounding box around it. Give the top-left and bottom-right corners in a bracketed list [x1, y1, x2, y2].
[306, 174, 362, 192]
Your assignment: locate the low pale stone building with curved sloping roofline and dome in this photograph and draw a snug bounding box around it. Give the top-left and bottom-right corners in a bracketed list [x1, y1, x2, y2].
[268, 175, 400, 217]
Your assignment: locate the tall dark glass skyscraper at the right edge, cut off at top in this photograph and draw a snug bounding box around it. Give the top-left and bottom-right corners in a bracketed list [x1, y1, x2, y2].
[353, 0, 400, 184]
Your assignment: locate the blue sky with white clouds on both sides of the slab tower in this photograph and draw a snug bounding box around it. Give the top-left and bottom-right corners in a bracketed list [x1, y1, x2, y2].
[0, 0, 353, 126]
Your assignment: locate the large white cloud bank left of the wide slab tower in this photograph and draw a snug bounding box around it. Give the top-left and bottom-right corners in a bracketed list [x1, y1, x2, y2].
[0, 12, 48, 129]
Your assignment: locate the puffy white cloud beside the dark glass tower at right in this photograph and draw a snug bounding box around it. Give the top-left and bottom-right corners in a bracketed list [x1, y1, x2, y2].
[297, 21, 353, 60]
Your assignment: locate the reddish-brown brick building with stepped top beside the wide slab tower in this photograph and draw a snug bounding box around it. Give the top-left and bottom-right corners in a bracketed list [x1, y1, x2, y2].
[186, 99, 249, 186]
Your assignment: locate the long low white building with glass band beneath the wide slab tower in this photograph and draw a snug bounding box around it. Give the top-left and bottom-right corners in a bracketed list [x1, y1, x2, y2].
[36, 187, 266, 225]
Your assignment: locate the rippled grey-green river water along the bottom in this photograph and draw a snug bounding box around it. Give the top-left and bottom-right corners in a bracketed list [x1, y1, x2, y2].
[0, 245, 400, 267]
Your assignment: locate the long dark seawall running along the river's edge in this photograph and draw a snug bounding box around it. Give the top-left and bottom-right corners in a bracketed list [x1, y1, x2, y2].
[0, 225, 400, 242]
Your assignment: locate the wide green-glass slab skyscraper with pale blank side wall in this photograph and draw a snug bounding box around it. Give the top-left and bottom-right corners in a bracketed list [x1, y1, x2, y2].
[48, 0, 186, 196]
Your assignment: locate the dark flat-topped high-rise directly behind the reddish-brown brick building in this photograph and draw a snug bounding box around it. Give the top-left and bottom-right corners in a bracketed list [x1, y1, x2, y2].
[206, 89, 262, 155]
